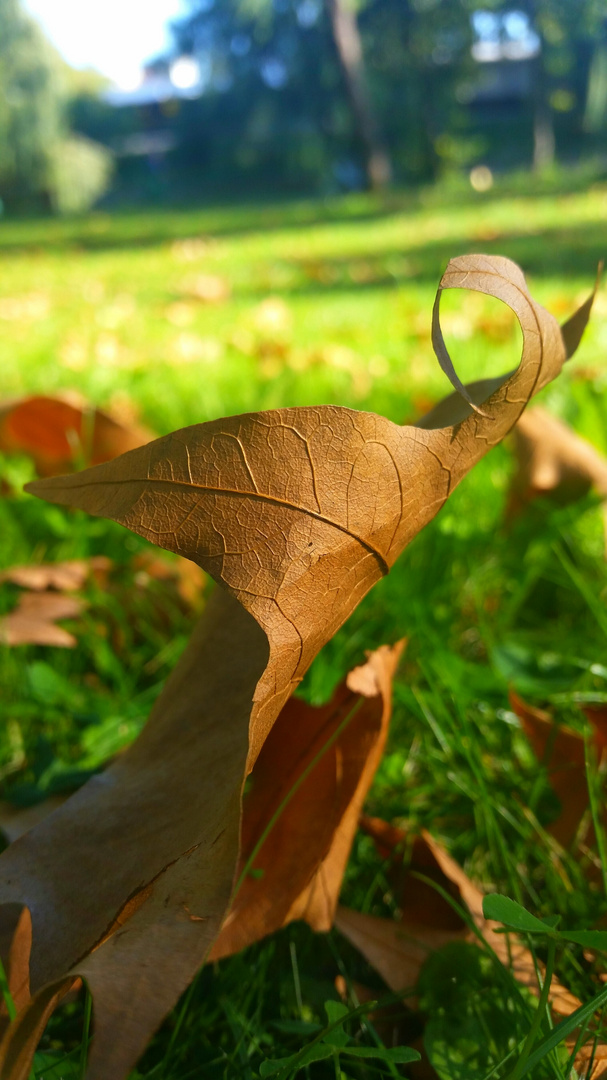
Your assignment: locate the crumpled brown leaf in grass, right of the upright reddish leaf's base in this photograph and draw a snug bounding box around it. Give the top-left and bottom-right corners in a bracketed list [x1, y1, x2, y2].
[335, 818, 581, 1016]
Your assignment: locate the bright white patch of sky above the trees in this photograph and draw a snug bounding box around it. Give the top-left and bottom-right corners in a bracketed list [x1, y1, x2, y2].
[24, 0, 184, 87]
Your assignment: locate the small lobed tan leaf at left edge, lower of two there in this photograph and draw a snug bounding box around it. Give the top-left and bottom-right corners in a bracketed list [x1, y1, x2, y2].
[0, 593, 86, 649]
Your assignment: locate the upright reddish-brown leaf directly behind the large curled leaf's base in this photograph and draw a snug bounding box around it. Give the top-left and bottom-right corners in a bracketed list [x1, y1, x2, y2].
[210, 644, 402, 960]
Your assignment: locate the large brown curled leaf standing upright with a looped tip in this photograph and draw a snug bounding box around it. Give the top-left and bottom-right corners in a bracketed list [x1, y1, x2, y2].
[0, 256, 583, 1080]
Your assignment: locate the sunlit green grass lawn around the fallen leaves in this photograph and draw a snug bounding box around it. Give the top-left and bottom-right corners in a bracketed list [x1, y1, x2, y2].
[0, 185, 607, 1080]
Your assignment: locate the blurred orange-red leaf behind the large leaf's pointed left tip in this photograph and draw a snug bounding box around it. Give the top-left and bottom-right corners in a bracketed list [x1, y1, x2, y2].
[0, 395, 152, 476]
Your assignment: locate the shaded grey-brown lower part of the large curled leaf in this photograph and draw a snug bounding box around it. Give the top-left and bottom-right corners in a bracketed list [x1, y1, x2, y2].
[0, 590, 268, 1080]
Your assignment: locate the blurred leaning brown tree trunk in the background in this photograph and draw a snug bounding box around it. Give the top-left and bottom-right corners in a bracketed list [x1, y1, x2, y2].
[326, 0, 392, 190]
